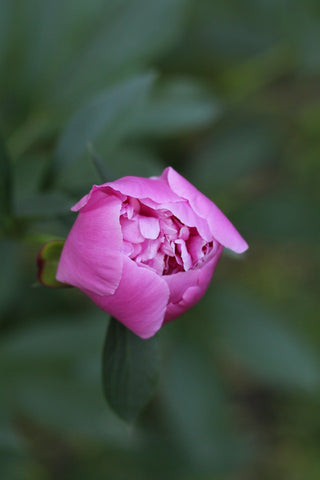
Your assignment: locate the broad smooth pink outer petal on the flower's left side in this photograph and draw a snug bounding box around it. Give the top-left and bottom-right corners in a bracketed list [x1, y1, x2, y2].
[56, 191, 122, 295]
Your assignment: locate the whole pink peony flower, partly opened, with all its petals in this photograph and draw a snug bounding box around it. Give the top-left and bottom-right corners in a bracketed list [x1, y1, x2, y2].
[56, 167, 248, 338]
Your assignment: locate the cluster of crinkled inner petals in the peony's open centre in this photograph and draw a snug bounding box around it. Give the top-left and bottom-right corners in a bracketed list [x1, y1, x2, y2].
[120, 197, 217, 275]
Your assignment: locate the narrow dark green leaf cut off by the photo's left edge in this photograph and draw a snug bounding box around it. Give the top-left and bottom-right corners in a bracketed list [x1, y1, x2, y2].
[0, 137, 12, 223]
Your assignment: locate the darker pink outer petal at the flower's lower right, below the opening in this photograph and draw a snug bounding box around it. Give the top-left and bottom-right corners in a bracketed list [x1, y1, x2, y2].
[163, 245, 223, 322]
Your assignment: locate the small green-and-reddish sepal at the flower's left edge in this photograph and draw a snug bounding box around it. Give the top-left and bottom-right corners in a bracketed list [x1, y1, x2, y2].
[37, 240, 67, 288]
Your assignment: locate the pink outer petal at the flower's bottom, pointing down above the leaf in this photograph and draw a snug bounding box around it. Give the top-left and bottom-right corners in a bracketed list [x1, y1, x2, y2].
[85, 256, 169, 338]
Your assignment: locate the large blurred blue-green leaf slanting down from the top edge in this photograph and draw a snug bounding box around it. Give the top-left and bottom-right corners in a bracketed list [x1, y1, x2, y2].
[54, 0, 190, 104]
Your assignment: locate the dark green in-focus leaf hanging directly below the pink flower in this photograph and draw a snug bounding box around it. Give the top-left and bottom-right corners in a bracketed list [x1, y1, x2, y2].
[102, 318, 160, 422]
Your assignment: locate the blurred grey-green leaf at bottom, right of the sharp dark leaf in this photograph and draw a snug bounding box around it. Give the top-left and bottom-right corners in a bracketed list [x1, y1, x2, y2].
[161, 344, 249, 472]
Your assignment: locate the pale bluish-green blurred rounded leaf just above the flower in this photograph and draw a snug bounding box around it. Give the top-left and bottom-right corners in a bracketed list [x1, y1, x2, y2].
[132, 78, 221, 136]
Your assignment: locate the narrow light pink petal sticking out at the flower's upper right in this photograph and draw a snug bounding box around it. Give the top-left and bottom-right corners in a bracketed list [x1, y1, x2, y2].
[162, 167, 248, 253]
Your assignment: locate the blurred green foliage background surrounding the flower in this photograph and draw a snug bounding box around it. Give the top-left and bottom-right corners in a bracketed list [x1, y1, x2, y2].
[0, 0, 320, 480]
